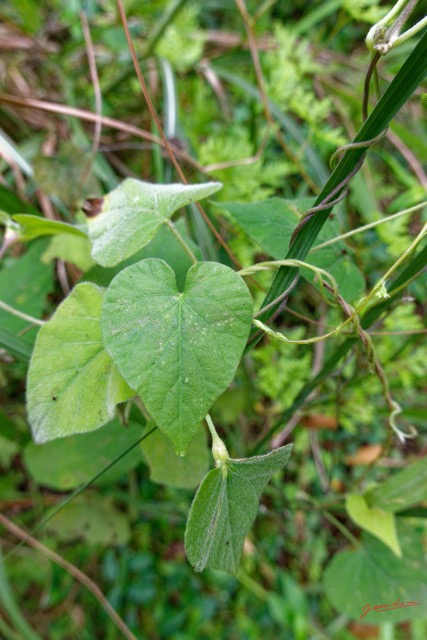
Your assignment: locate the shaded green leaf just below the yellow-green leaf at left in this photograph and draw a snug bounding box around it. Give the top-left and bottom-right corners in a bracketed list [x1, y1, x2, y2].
[24, 420, 142, 491]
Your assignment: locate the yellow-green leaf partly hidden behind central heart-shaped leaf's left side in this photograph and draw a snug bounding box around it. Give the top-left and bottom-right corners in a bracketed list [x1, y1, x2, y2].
[27, 283, 134, 442]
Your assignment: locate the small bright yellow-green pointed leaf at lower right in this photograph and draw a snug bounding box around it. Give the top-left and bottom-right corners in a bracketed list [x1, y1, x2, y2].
[345, 494, 402, 558]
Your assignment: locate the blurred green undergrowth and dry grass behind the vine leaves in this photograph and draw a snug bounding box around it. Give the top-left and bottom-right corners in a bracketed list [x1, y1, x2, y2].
[0, 0, 427, 640]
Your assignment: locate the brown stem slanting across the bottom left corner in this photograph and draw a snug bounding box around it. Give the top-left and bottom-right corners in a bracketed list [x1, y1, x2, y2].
[0, 514, 137, 640]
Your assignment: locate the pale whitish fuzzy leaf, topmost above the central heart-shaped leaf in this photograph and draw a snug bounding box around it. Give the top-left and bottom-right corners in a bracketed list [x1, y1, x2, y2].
[88, 178, 222, 267]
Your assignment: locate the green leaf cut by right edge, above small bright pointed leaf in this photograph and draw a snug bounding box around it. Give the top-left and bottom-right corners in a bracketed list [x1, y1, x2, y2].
[366, 457, 427, 512]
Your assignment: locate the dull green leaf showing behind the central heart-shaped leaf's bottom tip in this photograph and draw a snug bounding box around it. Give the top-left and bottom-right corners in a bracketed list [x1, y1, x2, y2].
[141, 422, 209, 489]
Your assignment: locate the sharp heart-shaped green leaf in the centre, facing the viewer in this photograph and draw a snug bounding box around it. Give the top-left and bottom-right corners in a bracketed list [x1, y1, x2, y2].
[102, 259, 253, 455]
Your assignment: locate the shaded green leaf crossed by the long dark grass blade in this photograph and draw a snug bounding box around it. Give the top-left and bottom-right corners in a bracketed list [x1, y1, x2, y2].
[218, 198, 365, 301]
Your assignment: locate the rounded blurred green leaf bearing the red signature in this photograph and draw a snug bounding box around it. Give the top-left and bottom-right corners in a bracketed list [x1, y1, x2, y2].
[324, 525, 427, 624]
